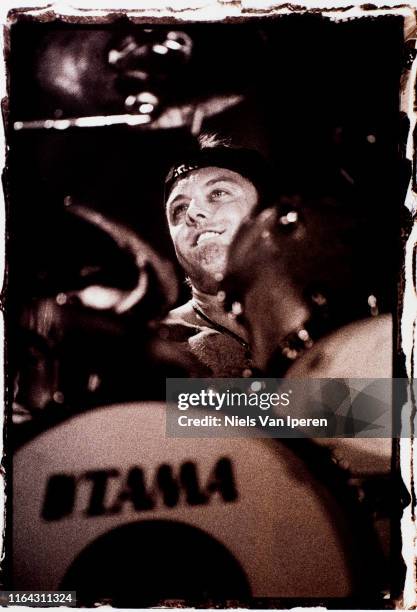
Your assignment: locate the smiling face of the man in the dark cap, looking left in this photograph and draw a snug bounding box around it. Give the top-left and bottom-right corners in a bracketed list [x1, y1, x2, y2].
[167, 167, 258, 293]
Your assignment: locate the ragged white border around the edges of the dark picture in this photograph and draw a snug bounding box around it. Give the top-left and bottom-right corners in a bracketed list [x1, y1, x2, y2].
[0, 0, 417, 610]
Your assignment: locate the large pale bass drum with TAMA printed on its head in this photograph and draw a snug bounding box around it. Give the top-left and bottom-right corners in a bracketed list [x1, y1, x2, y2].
[13, 403, 383, 607]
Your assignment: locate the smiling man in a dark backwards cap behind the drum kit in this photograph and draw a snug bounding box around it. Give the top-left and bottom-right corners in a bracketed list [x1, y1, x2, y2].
[163, 137, 272, 377]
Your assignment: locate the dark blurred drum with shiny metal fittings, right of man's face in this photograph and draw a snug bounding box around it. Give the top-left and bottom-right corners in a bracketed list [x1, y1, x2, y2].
[223, 199, 392, 377]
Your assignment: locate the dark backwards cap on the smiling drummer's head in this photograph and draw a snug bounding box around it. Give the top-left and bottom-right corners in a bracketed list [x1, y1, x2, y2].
[165, 143, 274, 208]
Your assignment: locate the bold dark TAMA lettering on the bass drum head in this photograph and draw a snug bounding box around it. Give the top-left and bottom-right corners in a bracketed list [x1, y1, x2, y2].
[41, 457, 238, 521]
